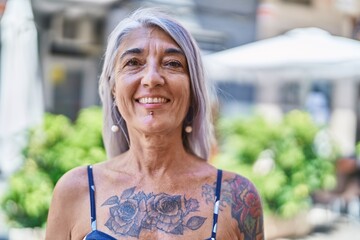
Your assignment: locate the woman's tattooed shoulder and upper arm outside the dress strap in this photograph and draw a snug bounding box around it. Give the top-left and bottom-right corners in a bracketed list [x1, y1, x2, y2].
[220, 171, 264, 240]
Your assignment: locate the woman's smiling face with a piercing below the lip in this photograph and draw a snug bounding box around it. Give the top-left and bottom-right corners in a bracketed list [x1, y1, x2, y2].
[113, 27, 190, 133]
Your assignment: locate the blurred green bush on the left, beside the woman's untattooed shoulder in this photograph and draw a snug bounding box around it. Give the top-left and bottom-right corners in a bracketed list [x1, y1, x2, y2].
[1, 107, 106, 227]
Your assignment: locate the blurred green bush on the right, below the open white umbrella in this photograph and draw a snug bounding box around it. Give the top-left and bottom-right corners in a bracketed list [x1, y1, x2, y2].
[214, 110, 338, 218]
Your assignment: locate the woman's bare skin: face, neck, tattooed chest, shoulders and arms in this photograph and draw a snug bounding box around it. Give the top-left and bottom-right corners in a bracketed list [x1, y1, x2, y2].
[46, 28, 264, 240]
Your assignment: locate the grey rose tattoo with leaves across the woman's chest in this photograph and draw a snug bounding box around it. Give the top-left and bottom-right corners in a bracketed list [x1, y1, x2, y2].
[102, 187, 206, 238]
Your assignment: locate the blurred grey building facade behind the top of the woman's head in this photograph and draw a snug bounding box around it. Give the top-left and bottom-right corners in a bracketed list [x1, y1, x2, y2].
[33, 0, 258, 119]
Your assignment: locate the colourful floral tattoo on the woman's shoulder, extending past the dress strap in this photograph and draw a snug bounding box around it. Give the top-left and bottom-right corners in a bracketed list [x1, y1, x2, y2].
[202, 176, 264, 240]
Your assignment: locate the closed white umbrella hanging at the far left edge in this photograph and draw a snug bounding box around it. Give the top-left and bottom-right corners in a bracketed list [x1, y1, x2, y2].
[0, 0, 43, 175]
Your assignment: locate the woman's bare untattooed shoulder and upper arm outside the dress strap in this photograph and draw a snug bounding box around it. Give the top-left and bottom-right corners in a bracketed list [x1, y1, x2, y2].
[46, 167, 88, 240]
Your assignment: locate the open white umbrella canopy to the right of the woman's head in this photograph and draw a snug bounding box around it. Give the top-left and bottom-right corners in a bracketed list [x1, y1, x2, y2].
[204, 28, 360, 155]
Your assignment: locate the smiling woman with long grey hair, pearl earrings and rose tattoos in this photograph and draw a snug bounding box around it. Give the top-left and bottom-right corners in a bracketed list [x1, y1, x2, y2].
[46, 9, 264, 240]
